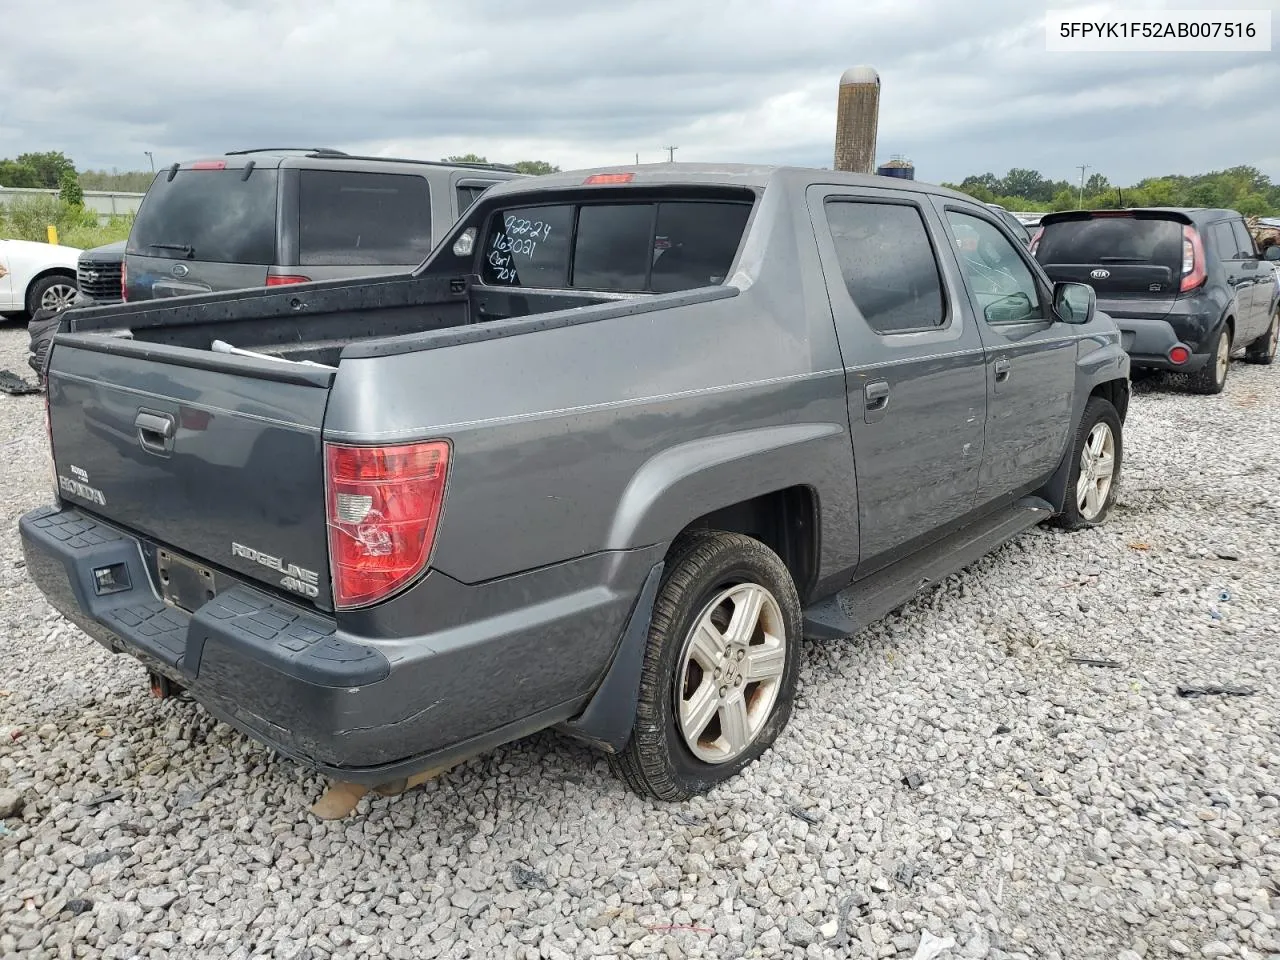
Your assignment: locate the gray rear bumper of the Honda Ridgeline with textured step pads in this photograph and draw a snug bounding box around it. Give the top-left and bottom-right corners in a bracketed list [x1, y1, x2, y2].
[19, 507, 648, 783]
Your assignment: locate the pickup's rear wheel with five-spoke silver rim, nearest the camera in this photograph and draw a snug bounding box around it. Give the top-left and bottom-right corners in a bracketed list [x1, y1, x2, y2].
[609, 531, 801, 800]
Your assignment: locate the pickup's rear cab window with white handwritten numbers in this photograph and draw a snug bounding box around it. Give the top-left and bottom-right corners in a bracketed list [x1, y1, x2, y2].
[480, 192, 751, 293]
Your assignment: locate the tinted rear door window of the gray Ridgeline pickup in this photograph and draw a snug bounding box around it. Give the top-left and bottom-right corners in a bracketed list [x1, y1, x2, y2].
[826, 200, 946, 334]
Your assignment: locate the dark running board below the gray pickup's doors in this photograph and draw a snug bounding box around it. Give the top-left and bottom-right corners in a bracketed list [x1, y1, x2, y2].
[804, 497, 1053, 640]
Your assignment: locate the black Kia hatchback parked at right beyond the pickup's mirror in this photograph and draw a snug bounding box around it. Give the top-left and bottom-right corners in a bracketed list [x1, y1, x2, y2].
[1030, 207, 1280, 393]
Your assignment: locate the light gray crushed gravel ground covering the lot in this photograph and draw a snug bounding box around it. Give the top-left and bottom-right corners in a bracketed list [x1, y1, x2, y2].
[0, 326, 1280, 960]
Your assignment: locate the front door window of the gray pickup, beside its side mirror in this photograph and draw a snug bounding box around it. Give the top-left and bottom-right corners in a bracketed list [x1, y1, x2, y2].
[947, 210, 1044, 324]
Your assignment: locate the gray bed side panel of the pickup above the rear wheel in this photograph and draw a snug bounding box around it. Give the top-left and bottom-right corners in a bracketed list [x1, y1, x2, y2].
[325, 181, 858, 582]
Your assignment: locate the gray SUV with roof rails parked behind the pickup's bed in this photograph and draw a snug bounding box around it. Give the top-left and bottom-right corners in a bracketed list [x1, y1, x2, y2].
[123, 148, 524, 301]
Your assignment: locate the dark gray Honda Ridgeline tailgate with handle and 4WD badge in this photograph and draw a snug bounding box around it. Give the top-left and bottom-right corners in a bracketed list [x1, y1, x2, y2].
[47, 334, 334, 609]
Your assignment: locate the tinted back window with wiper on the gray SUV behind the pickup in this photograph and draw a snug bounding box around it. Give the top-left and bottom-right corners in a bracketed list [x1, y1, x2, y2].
[125, 168, 279, 265]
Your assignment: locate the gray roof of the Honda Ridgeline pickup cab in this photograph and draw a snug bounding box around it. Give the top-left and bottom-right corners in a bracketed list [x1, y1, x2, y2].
[486, 163, 975, 202]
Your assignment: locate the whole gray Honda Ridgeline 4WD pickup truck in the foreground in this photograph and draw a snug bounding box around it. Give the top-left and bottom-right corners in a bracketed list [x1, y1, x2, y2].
[20, 164, 1129, 799]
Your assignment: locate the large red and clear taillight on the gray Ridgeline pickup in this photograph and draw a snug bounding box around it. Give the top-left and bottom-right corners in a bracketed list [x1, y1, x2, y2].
[325, 440, 449, 609]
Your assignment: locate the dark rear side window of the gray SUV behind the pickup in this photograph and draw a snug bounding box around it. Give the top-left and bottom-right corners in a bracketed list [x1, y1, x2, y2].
[298, 169, 431, 266]
